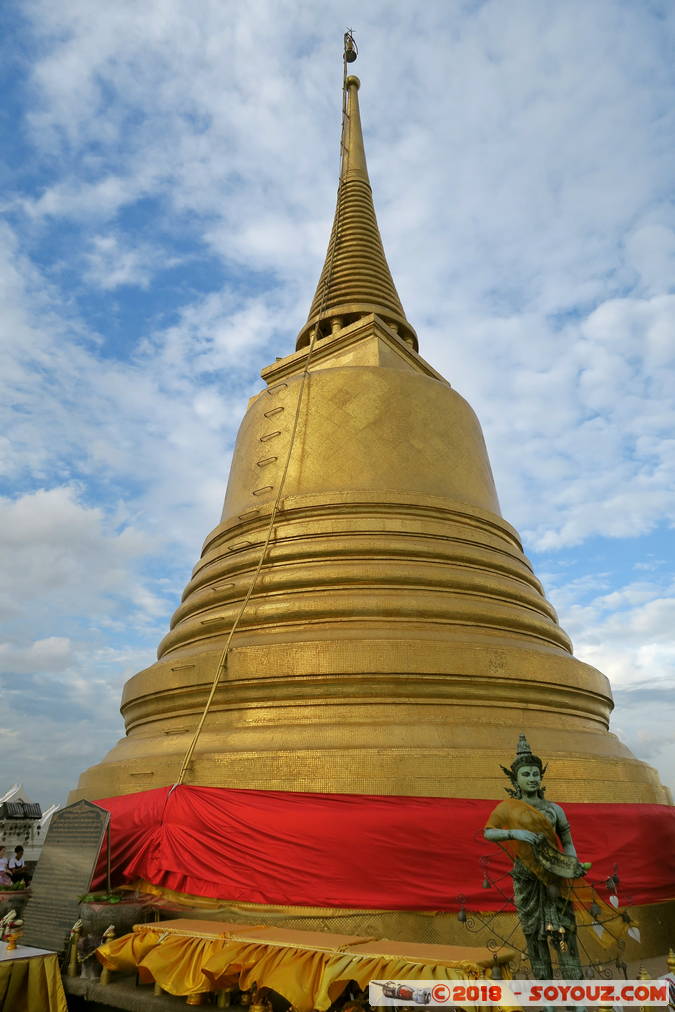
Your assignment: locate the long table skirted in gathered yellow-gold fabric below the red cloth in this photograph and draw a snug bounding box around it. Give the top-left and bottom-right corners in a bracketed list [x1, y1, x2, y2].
[92, 919, 513, 1012]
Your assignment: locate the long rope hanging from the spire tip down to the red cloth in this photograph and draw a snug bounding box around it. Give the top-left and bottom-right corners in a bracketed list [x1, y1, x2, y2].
[170, 28, 357, 792]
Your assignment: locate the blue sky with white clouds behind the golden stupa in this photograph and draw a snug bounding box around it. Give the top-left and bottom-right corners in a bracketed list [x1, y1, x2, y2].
[0, 0, 675, 804]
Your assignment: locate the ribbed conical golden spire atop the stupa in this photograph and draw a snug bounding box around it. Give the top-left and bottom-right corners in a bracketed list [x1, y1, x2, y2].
[297, 76, 417, 350]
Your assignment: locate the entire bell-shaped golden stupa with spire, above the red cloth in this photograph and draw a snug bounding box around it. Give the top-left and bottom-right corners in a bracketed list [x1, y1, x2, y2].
[71, 61, 670, 947]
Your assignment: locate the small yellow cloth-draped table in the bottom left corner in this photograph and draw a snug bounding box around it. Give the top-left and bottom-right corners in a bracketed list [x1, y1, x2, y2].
[0, 952, 68, 1012]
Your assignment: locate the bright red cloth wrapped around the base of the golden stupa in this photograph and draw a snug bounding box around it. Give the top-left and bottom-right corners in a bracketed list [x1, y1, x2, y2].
[96, 786, 675, 911]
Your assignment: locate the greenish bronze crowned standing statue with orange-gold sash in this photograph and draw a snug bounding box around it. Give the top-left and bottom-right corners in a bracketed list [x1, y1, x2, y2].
[483, 735, 590, 981]
